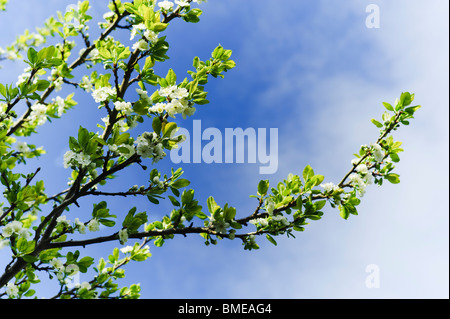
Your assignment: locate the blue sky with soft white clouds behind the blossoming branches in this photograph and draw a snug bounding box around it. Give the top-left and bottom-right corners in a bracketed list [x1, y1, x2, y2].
[0, 0, 449, 298]
